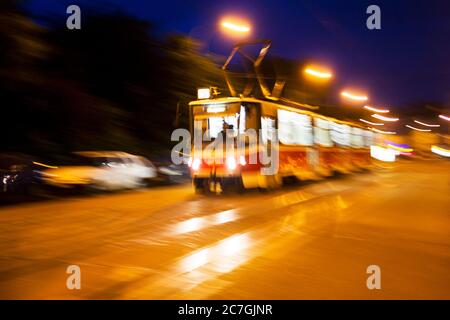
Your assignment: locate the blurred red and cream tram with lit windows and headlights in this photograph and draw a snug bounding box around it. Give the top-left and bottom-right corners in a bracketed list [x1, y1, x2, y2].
[189, 43, 377, 193]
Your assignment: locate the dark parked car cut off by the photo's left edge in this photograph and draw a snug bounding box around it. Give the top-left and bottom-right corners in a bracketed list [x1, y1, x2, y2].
[0, 153, 48, 197]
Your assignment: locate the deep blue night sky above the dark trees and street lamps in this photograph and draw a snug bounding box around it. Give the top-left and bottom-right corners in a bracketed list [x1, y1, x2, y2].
[24, 0, 450, 107]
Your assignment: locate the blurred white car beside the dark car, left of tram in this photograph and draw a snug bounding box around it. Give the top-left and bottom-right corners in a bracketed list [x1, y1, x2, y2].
[43, 151, 158, 190]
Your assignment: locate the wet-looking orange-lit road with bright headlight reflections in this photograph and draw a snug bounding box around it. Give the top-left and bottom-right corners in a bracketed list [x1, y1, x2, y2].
[0, 160, 450, 299]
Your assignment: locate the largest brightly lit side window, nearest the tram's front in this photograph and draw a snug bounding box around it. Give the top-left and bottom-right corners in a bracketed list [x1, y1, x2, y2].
[278, 109, 313, 146]
